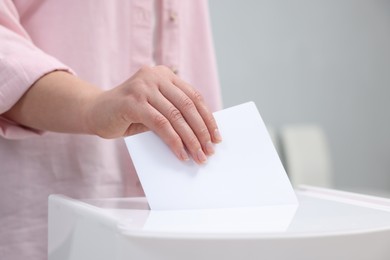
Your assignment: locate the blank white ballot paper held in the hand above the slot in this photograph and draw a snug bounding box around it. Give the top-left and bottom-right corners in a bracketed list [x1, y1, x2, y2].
[125, 102, 298, 210]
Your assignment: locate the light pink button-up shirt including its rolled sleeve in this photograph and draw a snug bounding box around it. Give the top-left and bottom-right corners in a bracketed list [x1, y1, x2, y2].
[0, 0, 221, 260]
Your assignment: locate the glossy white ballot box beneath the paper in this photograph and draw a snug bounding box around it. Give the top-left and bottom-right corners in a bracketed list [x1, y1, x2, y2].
[48, 187, 390, 260]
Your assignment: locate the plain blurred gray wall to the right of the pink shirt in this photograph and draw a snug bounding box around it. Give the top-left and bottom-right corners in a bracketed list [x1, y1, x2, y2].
[209, 0, 390, 191]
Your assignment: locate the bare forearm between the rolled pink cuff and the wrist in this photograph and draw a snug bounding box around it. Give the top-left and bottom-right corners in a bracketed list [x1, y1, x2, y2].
[3, 71, 101, 134]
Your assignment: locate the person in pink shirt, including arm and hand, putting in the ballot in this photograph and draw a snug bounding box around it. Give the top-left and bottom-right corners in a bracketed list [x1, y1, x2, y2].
[0, 0, 221, 260]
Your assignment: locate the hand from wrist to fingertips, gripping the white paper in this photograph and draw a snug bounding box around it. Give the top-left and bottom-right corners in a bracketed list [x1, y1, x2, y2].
[85, 66, 221, 163]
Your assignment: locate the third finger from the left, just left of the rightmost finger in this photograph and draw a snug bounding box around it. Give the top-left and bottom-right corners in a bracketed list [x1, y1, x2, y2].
[160, 82, 214, 155]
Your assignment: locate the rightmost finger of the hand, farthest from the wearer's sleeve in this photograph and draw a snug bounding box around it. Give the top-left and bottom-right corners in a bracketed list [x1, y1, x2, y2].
[173, 77, 222, 143]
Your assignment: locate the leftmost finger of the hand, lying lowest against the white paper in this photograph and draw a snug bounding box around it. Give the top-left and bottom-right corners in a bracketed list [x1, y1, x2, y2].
[138, 104, 189, 161]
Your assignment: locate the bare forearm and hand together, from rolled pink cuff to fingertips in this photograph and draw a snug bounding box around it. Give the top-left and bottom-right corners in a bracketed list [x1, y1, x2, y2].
[2, 66, 221, 163]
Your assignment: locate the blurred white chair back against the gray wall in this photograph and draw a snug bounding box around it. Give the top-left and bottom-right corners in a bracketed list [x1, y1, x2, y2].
[280, 125, 333, 188]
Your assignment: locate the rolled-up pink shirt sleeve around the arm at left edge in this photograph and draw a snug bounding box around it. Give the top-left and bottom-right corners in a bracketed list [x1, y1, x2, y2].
[0, 0, 72, 139]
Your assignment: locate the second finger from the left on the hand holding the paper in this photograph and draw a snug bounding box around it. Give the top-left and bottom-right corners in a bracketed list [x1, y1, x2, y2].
[149, 93, 207, 164]
